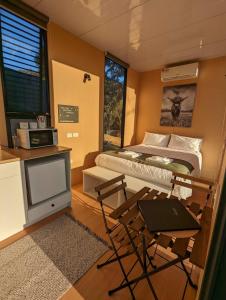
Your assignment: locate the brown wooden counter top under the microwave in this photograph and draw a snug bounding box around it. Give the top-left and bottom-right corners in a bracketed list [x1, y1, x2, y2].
[2, 146, 71, 160]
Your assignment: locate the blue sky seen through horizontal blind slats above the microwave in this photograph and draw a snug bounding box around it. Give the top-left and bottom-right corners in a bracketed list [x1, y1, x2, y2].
[0, 9, 40, 76]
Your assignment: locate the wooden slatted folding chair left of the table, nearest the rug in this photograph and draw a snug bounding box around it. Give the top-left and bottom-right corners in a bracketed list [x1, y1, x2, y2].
[95, 175, 157, 299]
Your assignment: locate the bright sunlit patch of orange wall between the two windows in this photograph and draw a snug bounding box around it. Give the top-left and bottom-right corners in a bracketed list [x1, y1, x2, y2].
[52, 60, 100, 168]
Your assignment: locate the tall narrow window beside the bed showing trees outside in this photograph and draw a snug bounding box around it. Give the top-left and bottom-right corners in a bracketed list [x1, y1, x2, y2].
[104, 57, 127, 150]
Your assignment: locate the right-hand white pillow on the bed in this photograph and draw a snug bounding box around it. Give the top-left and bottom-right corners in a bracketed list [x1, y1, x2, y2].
[168, 134, 202, 152]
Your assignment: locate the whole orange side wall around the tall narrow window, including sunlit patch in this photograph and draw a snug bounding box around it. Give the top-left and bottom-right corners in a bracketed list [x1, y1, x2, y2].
[48, 22, 139, 183]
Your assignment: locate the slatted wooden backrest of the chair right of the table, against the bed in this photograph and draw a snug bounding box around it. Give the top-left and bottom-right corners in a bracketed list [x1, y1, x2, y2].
[171, 172, 215, 206]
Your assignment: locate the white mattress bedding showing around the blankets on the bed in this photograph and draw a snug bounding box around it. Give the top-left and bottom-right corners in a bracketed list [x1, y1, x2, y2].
[95, 144, 202, 198]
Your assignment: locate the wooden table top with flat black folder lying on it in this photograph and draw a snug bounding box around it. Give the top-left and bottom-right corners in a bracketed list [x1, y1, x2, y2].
[138, 199, 201, 238]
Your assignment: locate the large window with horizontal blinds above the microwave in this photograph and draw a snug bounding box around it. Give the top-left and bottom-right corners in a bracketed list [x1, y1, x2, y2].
[0, 8, 49, 117]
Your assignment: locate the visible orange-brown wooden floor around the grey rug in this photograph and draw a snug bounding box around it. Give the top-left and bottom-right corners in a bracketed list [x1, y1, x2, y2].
[0, 186, 199, 300]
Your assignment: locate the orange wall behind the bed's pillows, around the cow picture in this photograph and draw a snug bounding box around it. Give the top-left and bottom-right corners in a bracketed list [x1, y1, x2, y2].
[136, 57, 226, 179]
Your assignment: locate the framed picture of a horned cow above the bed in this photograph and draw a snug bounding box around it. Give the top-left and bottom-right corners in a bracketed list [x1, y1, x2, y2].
[160, 83, 197, 127]
